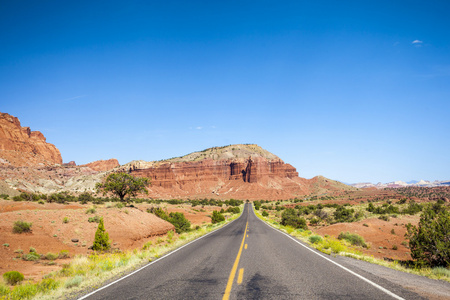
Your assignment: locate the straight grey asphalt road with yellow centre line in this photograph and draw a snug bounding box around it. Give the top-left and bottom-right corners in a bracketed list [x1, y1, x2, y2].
[80, 204, 440, 299]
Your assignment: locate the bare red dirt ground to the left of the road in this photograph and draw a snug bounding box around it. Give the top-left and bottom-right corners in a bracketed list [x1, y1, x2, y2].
[0, 200, 174, 279]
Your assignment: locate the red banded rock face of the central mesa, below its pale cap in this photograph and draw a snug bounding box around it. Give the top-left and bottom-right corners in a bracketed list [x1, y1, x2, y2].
[129, 157, 309, 199]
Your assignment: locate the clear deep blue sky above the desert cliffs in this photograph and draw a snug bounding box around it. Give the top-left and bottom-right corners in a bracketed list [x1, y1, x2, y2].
[0, 0, 450, 183]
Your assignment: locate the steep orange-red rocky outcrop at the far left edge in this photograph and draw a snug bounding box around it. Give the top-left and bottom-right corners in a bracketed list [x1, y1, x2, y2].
[0, 113, 62, 166]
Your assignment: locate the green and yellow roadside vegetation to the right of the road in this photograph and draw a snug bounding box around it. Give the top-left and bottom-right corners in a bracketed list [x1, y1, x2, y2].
[254, 197, 450, 282]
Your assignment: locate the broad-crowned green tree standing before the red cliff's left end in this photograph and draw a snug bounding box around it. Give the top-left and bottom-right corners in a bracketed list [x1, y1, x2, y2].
[95, 172, 150, 202]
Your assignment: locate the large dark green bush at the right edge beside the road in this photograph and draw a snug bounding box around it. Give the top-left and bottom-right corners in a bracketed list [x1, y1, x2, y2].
[405, 205, 450, 267]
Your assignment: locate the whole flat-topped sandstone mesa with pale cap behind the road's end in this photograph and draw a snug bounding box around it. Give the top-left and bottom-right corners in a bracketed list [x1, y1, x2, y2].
[121, 145, 338, 200]
